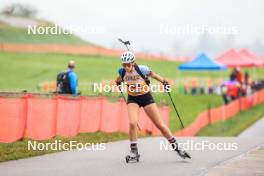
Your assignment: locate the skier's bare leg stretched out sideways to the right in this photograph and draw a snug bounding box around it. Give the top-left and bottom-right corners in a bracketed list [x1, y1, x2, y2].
[144, 103, 173, 140]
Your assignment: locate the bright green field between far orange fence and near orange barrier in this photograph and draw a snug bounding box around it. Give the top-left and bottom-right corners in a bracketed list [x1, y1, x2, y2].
[0, 53, 227, 131]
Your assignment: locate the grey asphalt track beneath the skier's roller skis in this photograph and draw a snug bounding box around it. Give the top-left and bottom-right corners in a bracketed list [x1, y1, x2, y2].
[0, 137, 264, 176]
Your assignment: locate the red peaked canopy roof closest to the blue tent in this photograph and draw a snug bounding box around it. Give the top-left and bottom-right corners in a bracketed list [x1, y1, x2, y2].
[215, 49, 254, 67]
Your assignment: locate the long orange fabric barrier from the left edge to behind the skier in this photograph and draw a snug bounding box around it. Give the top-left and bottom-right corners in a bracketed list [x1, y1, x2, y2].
[0, 95, 169, 143]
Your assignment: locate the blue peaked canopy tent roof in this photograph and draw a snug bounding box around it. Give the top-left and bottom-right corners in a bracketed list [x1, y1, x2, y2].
[178, 53, 226, 71]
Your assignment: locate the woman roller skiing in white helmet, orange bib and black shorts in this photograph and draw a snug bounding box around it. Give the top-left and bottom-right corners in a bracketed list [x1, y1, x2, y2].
[116, 51, 191, 162]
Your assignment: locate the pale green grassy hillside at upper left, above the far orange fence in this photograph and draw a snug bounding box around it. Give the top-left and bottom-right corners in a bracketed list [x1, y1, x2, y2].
[0, 25, 90, 45]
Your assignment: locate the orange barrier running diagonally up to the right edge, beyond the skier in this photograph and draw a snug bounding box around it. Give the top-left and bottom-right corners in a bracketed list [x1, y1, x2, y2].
[175, 90, 264, 136]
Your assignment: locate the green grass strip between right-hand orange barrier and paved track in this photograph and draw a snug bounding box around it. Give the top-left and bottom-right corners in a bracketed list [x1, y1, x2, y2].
[198, 104, 264, 136]
